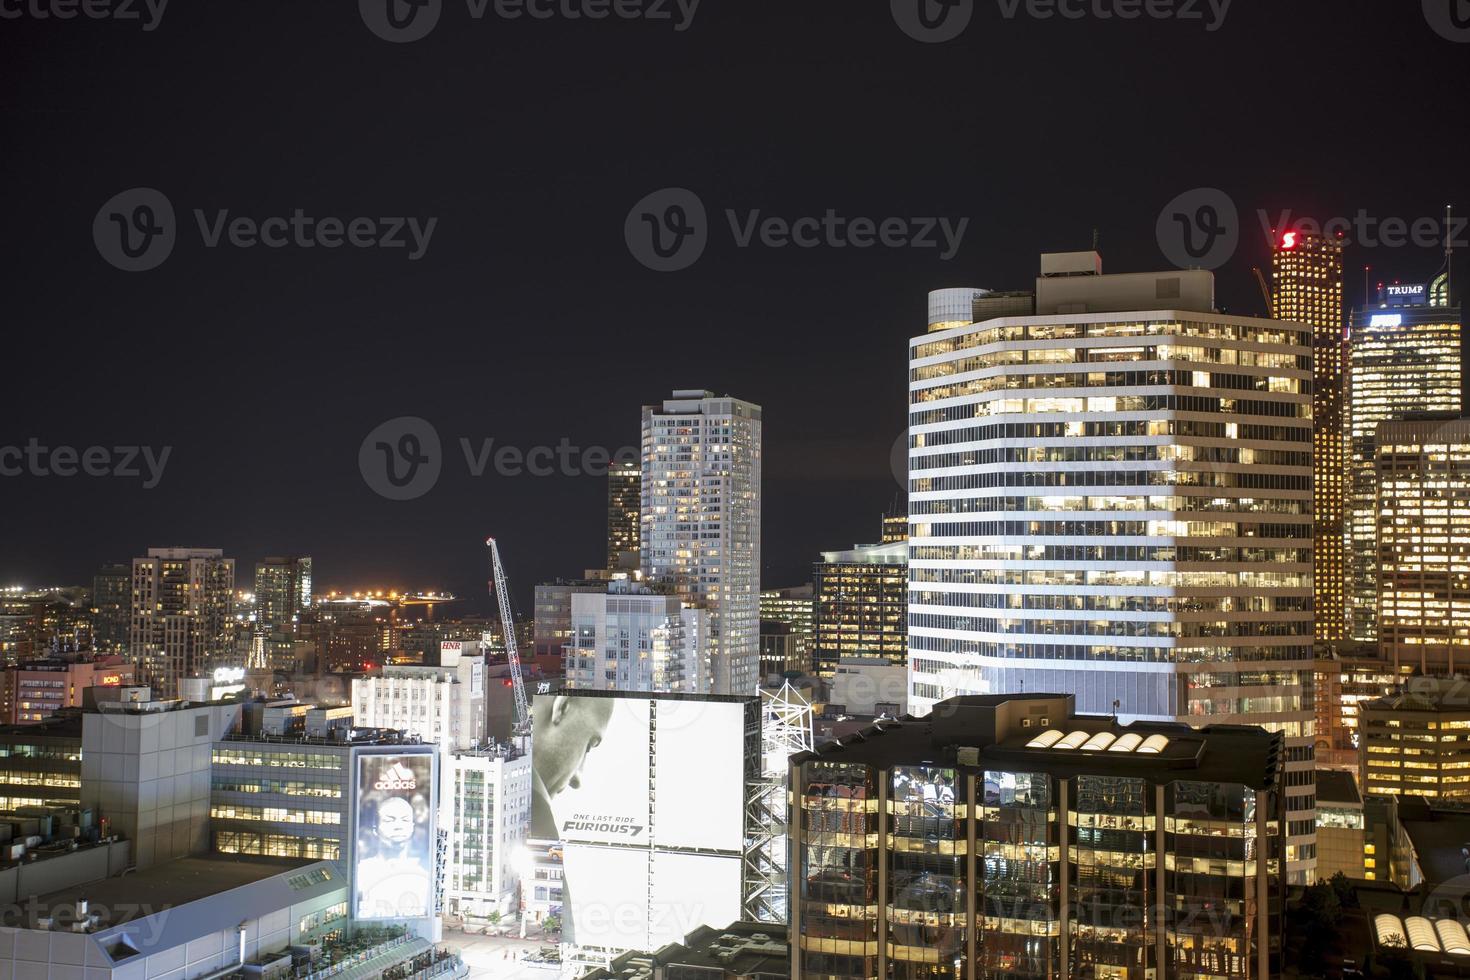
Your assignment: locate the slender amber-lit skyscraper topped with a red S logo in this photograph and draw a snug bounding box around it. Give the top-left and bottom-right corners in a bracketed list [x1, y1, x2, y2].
[1272, 232, 1348, 641]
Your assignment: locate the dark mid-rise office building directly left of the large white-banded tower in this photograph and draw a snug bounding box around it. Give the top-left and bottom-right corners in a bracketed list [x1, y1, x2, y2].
[811, 538, 908, 680]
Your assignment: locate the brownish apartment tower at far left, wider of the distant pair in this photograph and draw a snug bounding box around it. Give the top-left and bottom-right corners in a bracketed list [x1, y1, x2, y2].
[128, 548, 235, 698]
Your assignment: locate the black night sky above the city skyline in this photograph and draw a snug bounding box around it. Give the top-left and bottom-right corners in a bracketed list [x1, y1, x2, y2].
[0, 0, 1470, 607]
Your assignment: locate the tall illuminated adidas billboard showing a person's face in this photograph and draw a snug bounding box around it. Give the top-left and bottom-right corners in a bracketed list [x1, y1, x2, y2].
[353, 752, 435, 918]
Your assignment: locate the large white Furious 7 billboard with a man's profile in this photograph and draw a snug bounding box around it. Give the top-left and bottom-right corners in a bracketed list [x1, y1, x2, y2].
[531, 691, 760, 951]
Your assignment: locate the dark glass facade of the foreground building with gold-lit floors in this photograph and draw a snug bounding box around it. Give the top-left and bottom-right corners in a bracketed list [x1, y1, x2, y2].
[794, 746, 1285, 980]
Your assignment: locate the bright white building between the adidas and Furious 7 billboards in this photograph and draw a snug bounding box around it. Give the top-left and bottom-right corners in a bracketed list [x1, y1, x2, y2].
[445, 745, 531, 918]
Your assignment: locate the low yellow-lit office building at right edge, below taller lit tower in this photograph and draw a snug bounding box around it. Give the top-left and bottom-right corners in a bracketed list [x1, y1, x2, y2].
[1358, 677, 1470, 801]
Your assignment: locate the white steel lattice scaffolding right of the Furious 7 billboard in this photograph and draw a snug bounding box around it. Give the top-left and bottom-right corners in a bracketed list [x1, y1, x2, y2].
[745, 680, 814, 923]
